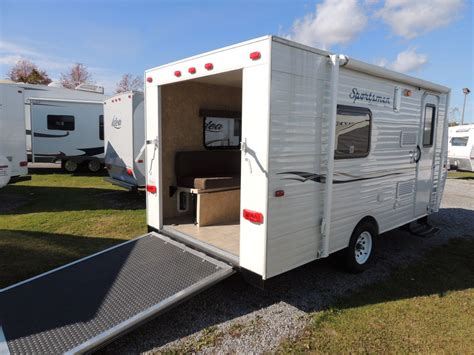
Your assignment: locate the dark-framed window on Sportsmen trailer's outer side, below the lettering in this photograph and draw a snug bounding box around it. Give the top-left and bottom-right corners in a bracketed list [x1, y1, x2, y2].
[334, 105, 372, 159]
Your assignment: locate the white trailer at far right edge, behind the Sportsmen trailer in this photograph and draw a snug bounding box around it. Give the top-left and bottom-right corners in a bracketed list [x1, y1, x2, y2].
[448, 124, 474, 171]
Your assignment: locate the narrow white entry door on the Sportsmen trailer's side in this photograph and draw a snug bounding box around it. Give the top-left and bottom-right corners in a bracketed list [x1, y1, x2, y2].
[415, 95, 438, 217]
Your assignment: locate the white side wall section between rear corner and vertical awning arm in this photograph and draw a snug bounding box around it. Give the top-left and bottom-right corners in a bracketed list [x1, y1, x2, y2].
[266, 42, 331, 277]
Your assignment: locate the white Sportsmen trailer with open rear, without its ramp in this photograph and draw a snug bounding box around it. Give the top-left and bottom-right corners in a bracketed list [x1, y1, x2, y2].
[145, 37, 449, 280]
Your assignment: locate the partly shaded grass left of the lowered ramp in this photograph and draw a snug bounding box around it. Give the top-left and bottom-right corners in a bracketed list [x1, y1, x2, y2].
[0, 174, 146, 288]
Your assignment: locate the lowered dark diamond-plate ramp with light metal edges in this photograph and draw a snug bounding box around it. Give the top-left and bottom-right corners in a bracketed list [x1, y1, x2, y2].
[0, 233, 234, 354]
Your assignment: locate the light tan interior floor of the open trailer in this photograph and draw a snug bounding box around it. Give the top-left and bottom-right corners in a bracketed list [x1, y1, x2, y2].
[165, 216, 240, 256]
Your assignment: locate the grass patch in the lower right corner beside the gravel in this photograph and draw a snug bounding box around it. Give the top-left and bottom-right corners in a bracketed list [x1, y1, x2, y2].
[280, 239, 474, 354]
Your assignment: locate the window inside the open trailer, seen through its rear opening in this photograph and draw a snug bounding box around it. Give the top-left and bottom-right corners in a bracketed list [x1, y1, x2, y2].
[200, 110, 242, 149]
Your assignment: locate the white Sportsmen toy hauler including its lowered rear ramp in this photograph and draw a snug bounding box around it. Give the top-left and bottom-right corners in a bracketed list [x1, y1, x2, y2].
[0, 36, 449, 353]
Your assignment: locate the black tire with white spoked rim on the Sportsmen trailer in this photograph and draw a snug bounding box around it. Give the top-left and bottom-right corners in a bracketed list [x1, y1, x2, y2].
[344, 220, 377, 274]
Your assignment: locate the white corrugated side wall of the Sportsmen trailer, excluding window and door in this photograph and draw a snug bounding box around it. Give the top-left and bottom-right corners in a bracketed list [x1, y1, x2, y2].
[266, 38, 447, 277]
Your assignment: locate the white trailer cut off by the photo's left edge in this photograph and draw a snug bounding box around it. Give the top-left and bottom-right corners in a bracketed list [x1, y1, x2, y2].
[0, 83, 28, 181]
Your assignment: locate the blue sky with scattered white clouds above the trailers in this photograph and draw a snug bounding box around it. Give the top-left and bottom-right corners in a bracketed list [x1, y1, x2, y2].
[0, 0, 474, 123]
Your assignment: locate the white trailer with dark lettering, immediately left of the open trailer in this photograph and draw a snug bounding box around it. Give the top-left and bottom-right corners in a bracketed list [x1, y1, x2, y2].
[104, 91, 145, 190]
